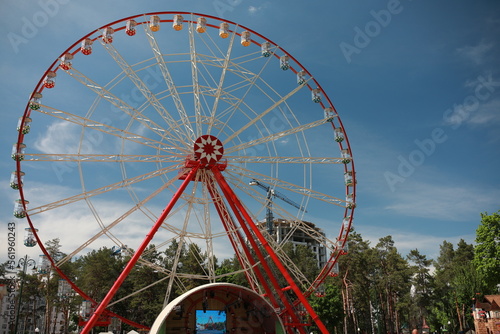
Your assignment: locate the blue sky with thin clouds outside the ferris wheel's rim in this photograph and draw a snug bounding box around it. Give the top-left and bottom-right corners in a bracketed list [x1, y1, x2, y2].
[0, 0, 500, 268]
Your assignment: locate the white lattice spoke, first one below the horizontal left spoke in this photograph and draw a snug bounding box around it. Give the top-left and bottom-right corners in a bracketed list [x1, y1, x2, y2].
[28, 164, 181, 215]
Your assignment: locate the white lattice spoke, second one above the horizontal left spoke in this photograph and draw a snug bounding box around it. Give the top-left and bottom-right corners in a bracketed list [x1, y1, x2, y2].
[66, 68, 185, 147]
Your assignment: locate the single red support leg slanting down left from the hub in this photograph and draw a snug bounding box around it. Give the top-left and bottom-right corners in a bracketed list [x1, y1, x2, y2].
[81, 164, 200, 334]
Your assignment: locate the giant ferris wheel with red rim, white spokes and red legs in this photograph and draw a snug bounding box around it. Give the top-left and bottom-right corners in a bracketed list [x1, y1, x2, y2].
[11, 12, 356, 332]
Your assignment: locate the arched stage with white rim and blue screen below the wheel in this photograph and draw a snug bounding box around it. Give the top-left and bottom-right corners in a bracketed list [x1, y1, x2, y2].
[150, 283, 285, 334]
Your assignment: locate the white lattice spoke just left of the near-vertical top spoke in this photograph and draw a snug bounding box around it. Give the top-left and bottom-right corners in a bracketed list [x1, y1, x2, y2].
[143, 20, 195, 141]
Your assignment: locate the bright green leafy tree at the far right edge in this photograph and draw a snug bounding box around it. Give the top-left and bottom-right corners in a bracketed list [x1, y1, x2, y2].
[473, 211, 500, 293]
